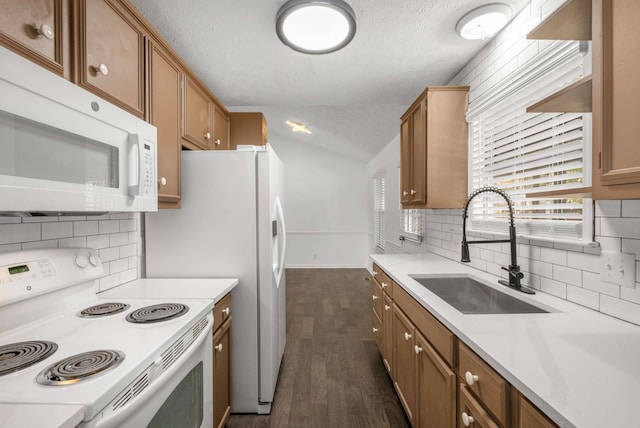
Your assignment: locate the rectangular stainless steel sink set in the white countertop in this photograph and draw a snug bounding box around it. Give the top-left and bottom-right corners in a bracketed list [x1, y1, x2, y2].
[411, 276, 549, 314]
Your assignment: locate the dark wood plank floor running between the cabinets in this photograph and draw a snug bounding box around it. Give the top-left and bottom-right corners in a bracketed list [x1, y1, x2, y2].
[227, 269, 410, 428]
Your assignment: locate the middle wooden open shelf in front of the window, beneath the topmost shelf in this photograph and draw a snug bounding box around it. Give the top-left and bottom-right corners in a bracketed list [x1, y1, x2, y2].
[527, 75, 591, 113]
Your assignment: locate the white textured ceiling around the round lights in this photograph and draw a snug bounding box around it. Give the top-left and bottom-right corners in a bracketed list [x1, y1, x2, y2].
[132, 0, 528, 161]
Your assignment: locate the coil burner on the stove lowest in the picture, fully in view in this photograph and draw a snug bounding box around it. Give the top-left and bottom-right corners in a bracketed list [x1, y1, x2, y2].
[36, 350, 124, 386]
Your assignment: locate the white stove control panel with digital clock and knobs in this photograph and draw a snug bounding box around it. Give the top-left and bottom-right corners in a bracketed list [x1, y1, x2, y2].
[0, 248, 104, 306]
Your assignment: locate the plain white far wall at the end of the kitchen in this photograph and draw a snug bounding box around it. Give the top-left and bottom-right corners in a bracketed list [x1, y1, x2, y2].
[270, 136, 370, 268]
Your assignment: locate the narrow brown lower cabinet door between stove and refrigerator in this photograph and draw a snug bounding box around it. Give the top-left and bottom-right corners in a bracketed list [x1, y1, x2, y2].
[213, 319, 231, 428]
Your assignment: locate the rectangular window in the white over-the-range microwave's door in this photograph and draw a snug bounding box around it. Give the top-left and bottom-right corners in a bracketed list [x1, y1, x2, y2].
[0, 111, 119, 188]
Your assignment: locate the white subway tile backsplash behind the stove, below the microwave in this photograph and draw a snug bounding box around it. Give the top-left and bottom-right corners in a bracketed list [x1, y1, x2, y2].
[0, 213, 143, 291]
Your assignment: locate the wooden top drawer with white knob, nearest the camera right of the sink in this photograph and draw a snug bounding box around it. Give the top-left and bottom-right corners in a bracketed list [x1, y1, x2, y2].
[458, 343, 509, 426]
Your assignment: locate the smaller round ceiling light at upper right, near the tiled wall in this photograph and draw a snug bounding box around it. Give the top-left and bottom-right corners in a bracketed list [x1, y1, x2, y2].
[456, 3, 511, 40]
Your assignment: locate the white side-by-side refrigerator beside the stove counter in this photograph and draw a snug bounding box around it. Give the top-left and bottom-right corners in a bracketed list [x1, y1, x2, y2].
[145, 146, 286, 414]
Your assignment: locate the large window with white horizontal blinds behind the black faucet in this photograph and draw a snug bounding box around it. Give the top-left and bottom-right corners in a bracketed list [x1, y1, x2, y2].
[467, 42, 591, 241]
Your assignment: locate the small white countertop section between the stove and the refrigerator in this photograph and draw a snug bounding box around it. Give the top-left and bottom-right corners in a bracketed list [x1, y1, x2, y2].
[98, 278, 238, 304]
